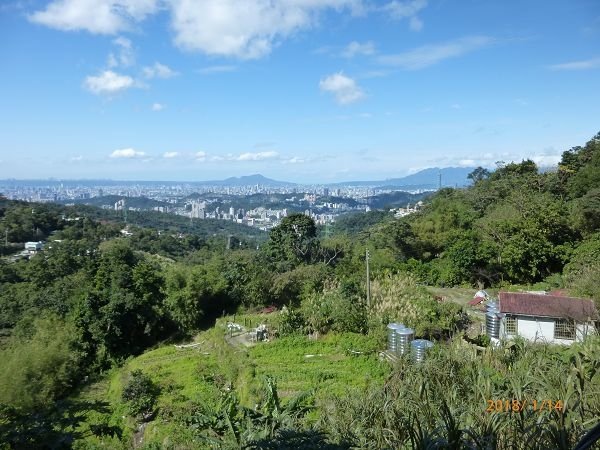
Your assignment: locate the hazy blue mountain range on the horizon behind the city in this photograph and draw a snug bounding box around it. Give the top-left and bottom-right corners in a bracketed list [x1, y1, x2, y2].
[0, 167, 474, 190]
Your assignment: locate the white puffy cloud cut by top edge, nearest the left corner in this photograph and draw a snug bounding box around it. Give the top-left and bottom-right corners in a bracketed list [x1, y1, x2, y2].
[29, 0, 158, 34]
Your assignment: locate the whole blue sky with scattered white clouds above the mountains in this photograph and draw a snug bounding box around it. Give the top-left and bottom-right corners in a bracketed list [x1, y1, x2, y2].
[0, 0, 600, 182]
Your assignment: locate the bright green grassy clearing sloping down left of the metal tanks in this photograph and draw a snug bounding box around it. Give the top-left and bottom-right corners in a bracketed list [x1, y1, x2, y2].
[69, 316, 390, 448]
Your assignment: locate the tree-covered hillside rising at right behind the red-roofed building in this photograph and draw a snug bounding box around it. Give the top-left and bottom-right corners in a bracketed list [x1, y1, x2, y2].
[394, 135, 600, 297]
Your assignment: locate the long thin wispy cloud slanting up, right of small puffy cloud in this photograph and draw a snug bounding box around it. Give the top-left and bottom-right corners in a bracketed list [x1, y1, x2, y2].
[378, 36, 494, 70]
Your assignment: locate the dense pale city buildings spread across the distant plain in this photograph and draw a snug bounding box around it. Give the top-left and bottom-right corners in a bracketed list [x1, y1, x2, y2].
[0, 177, 435, 231]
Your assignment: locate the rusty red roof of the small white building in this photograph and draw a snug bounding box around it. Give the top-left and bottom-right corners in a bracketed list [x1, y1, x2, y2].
[498, 292, 600, 322]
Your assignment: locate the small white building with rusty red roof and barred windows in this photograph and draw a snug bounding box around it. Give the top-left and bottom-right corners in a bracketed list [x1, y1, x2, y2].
[498, 292, 600, 345]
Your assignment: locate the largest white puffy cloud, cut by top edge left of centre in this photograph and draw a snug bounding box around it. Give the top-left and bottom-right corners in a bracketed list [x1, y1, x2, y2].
[170, 0, 361, 59]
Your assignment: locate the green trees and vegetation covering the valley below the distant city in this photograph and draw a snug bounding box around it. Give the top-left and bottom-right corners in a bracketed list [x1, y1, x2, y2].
[0, 134, 600, 449]
